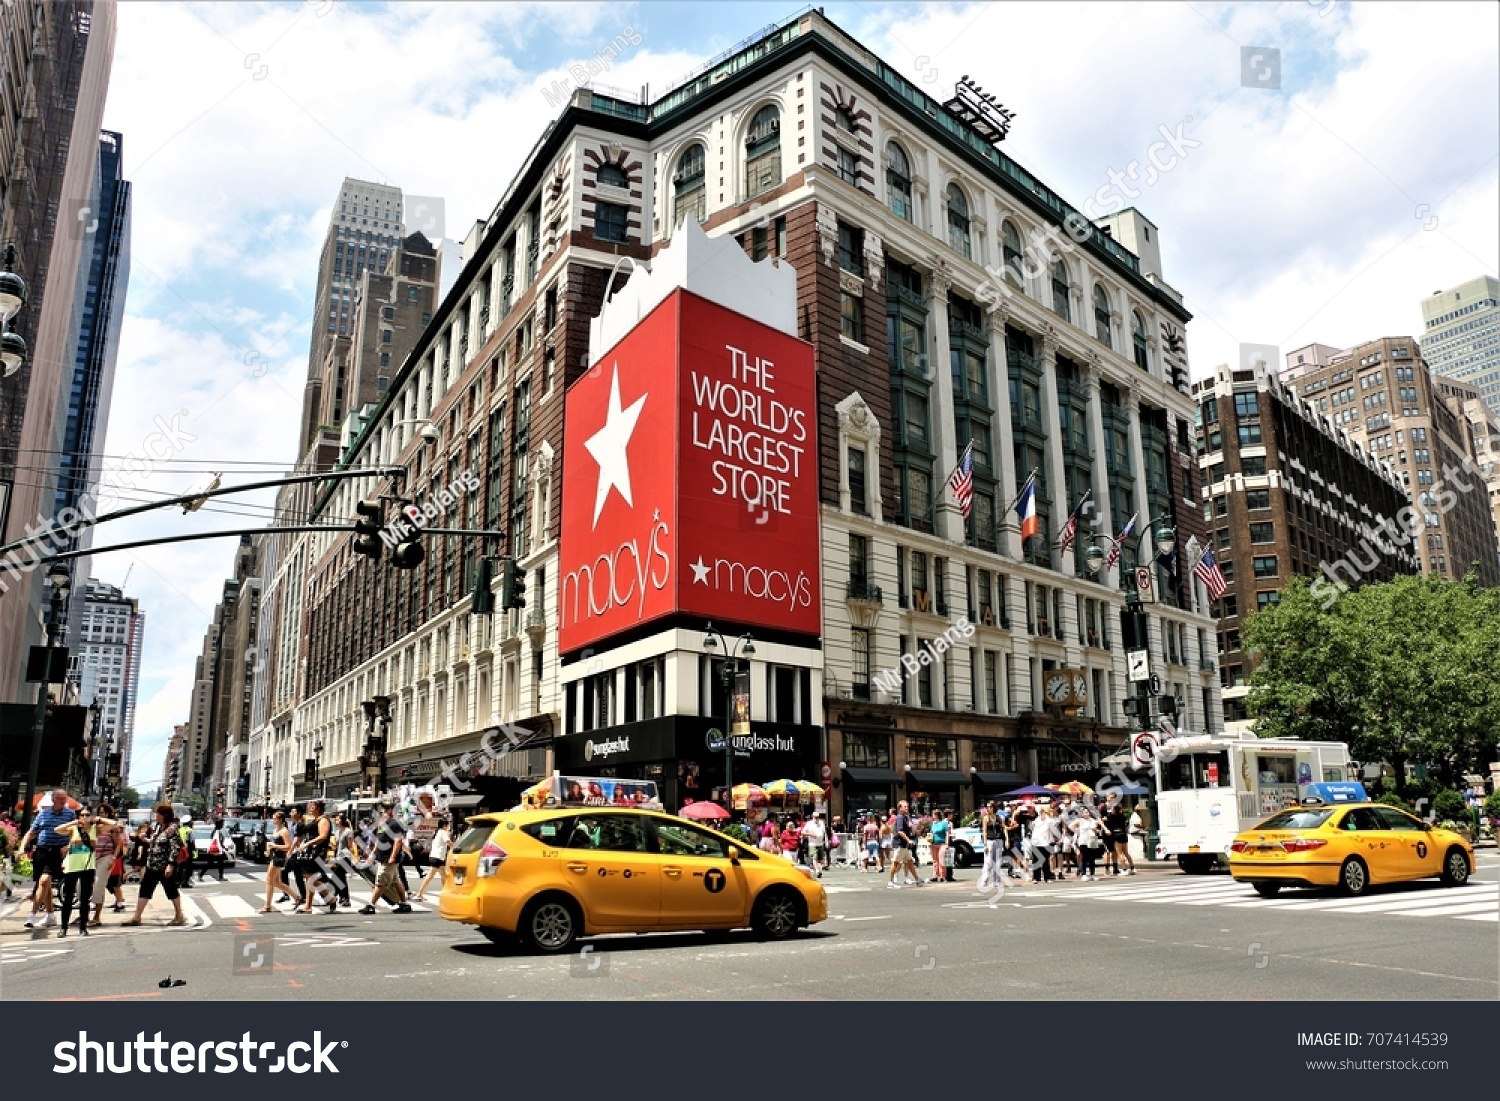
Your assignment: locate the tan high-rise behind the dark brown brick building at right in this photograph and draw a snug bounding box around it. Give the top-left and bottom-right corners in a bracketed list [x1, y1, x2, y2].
[1287, 336, 1500, 585]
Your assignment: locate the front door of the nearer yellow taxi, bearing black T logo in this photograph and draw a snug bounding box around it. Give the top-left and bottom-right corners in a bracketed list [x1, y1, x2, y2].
[651, 818, 750, 929]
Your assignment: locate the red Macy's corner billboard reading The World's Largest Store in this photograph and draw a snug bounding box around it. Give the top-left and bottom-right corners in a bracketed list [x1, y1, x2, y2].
[558, 290, 822, 654]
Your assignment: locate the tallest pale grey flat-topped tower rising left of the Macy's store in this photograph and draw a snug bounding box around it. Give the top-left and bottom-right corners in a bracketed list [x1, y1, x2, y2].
[297, 177, 402, 459]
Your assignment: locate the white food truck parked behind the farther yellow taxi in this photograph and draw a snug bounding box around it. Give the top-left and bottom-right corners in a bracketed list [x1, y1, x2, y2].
[1157, 737, 1356, 875]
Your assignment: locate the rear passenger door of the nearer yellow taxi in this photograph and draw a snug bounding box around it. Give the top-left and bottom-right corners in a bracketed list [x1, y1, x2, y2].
[558, 812, 662, 932]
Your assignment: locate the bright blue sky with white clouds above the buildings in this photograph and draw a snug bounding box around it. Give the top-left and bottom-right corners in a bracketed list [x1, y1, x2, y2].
[93, 0, 1500, 783]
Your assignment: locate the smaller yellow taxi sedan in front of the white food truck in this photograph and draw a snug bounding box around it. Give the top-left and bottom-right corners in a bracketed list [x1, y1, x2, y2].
[1229, 803, 1475, 899]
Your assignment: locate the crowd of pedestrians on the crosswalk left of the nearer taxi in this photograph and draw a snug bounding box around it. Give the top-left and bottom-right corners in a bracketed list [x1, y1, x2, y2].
[7, 789, 456, 936]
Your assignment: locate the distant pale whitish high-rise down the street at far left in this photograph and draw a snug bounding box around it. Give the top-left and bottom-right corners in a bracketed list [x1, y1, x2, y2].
[69, 578, 146, 780]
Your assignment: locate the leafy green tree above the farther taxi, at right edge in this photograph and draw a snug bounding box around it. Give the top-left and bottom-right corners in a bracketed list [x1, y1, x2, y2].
[1245, 576, 1500, 798]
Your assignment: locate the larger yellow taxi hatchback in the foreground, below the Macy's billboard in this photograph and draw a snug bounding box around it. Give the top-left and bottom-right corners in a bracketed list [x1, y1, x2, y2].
[438, 807, 828, 953]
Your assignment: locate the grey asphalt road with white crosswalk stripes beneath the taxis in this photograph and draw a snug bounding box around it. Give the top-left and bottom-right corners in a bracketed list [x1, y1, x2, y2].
[0, 851, 1500, 1002]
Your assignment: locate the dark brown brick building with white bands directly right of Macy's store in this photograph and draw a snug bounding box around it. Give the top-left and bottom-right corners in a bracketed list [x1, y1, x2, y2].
[1193, 363, 1419, 726]
